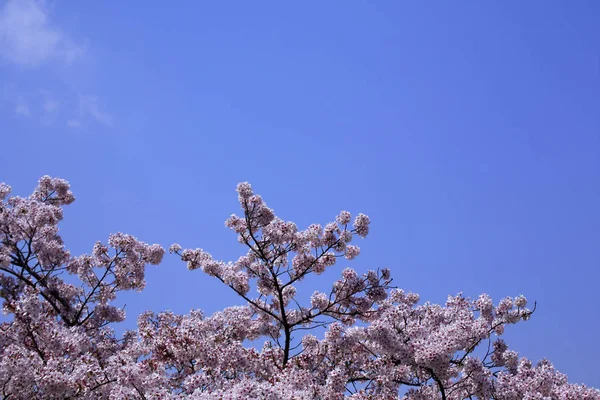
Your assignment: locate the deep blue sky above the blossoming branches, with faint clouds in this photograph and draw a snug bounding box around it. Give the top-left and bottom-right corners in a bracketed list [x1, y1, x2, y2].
[0, 0, 600, 386]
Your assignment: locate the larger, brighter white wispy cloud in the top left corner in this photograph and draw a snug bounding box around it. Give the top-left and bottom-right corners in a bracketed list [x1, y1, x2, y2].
[0, 0, 85, 67]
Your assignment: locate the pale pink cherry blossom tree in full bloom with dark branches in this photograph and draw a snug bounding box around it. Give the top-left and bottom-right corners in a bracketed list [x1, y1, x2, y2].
[0, 176, 600, 400]
